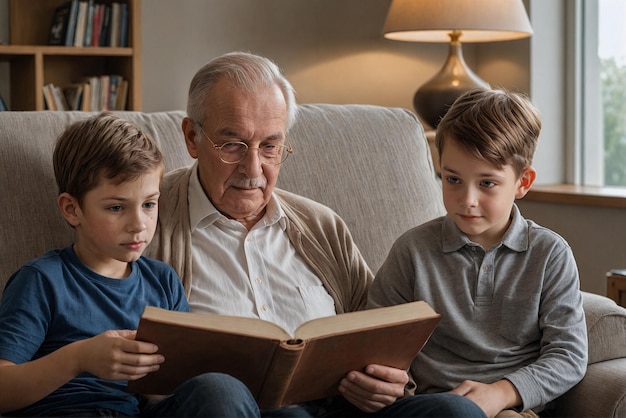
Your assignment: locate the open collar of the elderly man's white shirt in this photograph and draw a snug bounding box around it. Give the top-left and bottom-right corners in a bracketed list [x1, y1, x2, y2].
[188, 161, 286, 231]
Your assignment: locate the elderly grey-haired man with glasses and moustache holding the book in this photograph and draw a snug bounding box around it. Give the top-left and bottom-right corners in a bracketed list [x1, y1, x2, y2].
[148, 52, 482, 417]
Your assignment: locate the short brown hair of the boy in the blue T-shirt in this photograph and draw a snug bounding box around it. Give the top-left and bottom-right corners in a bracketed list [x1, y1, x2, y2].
[52, 112, 163, 204]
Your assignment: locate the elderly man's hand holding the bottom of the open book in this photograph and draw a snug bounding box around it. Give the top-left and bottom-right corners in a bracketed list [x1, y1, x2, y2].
[339, 364, 409, 413]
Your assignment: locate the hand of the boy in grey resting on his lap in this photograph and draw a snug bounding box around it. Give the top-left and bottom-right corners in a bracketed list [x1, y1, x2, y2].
[450, 379, 522, 418]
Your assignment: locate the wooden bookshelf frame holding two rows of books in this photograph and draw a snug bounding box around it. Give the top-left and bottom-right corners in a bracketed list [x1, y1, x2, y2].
[0, 0, 141, 110]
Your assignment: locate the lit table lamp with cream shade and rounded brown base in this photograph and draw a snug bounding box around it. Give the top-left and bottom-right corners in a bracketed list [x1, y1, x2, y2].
[384, 0, 533, 128]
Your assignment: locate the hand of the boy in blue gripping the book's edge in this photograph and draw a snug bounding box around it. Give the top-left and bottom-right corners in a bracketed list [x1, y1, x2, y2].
[75, 330, 165, 380]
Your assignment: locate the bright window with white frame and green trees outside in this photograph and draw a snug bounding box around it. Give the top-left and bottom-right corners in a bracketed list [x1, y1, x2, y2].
[570, 0, 626, 187]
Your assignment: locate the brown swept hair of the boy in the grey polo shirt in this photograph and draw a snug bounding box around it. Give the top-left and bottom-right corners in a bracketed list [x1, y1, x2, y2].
[435, 88, 541, 175]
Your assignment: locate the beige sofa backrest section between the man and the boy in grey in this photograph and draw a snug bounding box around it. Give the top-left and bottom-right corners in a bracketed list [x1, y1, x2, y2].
[278, 104, 444, 273]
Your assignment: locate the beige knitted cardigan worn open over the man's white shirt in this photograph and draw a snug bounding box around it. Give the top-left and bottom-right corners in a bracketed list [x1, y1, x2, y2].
[145, 167, 373, 313]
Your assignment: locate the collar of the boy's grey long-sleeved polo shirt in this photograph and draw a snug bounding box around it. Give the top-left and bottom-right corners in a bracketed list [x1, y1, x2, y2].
[442, 204, 528, 253]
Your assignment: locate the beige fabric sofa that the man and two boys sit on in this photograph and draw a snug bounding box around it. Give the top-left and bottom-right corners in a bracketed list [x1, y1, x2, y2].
[0, 104, 626, 418]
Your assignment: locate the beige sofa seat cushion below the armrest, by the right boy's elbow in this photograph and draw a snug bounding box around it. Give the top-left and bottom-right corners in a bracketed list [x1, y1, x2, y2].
[553, 356, 626, 418]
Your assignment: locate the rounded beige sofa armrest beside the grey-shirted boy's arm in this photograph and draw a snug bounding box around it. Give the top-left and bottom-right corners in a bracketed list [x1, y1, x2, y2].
[583, 292, 626, 364]
